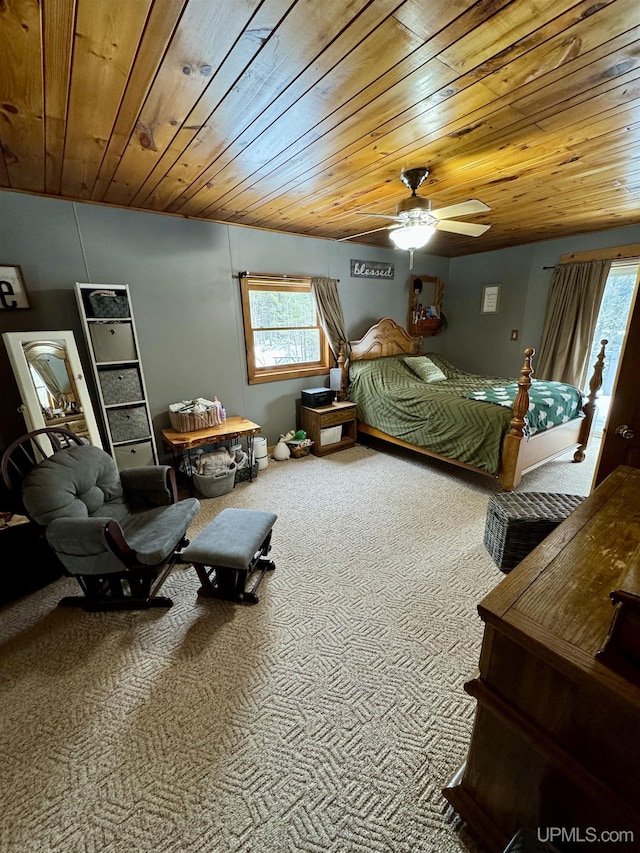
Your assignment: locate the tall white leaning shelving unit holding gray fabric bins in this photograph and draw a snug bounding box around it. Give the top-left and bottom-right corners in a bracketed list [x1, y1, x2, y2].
[76, 282, 158, 470]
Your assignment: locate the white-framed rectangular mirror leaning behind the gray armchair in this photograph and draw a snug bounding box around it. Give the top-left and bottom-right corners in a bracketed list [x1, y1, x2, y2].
[2, 331, 102, 447]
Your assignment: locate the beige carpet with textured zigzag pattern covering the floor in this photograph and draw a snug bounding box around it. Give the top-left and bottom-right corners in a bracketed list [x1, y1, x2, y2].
[0, 446, 594, 853]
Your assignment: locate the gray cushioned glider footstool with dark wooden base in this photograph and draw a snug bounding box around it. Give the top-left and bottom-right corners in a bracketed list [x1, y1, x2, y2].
[180, 509, 278, 604]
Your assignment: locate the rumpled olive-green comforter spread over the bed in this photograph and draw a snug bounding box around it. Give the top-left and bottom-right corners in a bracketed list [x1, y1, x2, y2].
[349, 353, 581, 475]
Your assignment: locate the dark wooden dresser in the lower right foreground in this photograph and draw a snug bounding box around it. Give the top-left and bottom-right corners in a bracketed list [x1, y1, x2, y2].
[444, 467, 640, 853]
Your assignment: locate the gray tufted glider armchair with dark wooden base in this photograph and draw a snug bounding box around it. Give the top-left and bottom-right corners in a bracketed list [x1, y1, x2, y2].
[3, 436, 200, 610]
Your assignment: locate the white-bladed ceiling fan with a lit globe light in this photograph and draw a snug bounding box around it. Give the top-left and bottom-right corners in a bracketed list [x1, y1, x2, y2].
[338, 168, 491, 265]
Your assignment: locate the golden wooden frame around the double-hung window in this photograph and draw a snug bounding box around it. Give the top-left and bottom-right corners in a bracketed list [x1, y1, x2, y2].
[239, 273, 333, 385]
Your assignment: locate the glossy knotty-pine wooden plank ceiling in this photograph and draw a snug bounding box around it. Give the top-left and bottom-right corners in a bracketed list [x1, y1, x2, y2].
[0, 0, 640, 257]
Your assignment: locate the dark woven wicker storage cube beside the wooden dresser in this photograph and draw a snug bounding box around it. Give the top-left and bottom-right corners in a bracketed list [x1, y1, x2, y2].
[484, 492, 584, 572]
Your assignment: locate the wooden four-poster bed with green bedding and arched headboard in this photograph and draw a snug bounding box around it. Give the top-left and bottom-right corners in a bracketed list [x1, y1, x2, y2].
[339, 318, 606, 491]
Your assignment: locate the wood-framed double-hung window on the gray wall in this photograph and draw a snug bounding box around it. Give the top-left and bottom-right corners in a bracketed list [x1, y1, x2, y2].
[240, 273, 331, 385]
